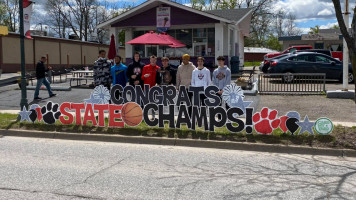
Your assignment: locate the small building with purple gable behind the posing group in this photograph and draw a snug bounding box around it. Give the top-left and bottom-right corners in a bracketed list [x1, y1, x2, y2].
[97, 0, 252, 65]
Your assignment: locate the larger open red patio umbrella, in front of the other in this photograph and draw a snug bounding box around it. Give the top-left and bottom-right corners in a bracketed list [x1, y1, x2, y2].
[126, 31, 173, 45]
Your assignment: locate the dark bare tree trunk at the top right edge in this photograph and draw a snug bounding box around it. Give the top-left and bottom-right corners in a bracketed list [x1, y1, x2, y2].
[332, 0, 356, 103]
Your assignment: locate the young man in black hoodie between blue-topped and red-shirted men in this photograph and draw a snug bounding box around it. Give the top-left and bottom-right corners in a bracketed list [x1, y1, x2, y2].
[126, 52, 145, 88]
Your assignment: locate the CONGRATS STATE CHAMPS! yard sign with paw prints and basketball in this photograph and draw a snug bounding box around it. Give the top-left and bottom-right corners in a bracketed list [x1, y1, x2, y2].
[19, 84, 333, 135]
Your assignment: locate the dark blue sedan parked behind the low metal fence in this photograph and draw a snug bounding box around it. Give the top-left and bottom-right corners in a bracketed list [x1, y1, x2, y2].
[267, 52, 354, 83]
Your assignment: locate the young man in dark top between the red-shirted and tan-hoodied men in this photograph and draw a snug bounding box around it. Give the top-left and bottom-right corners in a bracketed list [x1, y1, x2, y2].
[156, 57, 177, 85]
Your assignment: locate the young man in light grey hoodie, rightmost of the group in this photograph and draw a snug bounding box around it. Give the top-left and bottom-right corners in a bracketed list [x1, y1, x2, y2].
[213, 56, 231, 110]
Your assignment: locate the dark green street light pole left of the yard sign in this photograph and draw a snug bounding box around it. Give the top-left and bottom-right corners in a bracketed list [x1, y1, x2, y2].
[19, 0, 28, 110]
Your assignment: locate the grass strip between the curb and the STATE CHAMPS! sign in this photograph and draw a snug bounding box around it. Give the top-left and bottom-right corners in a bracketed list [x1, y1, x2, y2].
[0, 113, 356, 149]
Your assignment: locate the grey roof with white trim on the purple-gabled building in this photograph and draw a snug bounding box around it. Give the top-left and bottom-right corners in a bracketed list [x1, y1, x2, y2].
[97, 0, 252, 28]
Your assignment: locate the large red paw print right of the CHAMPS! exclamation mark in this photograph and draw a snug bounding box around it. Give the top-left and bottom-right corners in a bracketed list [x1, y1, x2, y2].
[252, 108, 281, 134]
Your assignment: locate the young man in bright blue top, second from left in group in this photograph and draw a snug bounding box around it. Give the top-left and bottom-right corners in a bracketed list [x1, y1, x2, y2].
[111, 56, 127, 88]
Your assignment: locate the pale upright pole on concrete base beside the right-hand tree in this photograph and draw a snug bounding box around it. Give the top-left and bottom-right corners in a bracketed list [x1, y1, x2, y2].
[342, 0, 350, 91]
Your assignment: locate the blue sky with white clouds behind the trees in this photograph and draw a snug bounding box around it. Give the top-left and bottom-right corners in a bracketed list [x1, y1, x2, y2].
[35, 0, 356, 33]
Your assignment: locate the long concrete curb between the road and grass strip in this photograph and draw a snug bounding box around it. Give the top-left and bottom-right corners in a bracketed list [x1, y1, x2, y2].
[0, 129, 356, 157]
